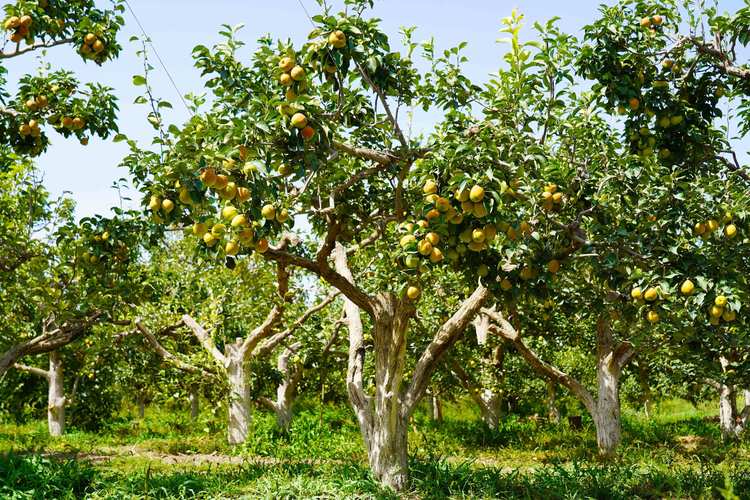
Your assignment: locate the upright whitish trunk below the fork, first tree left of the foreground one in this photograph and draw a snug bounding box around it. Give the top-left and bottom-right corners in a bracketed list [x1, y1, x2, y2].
[225, 338, 252, 444]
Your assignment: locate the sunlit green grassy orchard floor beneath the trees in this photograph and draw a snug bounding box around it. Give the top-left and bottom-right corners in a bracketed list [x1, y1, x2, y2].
[0, 401, 750, 499]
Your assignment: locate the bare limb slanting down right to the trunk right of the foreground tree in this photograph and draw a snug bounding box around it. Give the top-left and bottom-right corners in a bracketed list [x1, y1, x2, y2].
[482, 308, 596, 415]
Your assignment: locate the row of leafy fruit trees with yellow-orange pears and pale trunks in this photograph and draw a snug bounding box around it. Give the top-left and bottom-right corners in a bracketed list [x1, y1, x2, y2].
[0, 0, 750, 489]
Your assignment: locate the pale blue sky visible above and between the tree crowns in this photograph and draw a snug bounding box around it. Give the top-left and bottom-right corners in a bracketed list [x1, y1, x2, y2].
[7, 0, 743, 216]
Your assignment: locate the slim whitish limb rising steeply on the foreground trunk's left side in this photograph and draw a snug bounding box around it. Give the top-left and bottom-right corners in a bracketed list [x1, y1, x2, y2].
[333, 243, 372, 420]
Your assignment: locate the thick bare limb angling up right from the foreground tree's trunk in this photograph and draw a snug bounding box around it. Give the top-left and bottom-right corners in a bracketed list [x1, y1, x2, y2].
[402, 285, 491, 417]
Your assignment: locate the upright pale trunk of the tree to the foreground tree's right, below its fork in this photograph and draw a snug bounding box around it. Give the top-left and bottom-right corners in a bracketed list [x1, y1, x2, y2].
[591, 357, 621, 458]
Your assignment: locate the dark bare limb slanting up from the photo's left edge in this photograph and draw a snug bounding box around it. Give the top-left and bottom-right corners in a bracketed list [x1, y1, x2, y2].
[0, 311, 105, 375]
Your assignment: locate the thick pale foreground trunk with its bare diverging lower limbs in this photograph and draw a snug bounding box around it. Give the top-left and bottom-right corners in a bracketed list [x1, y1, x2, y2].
[333, 242, 490, 491]
